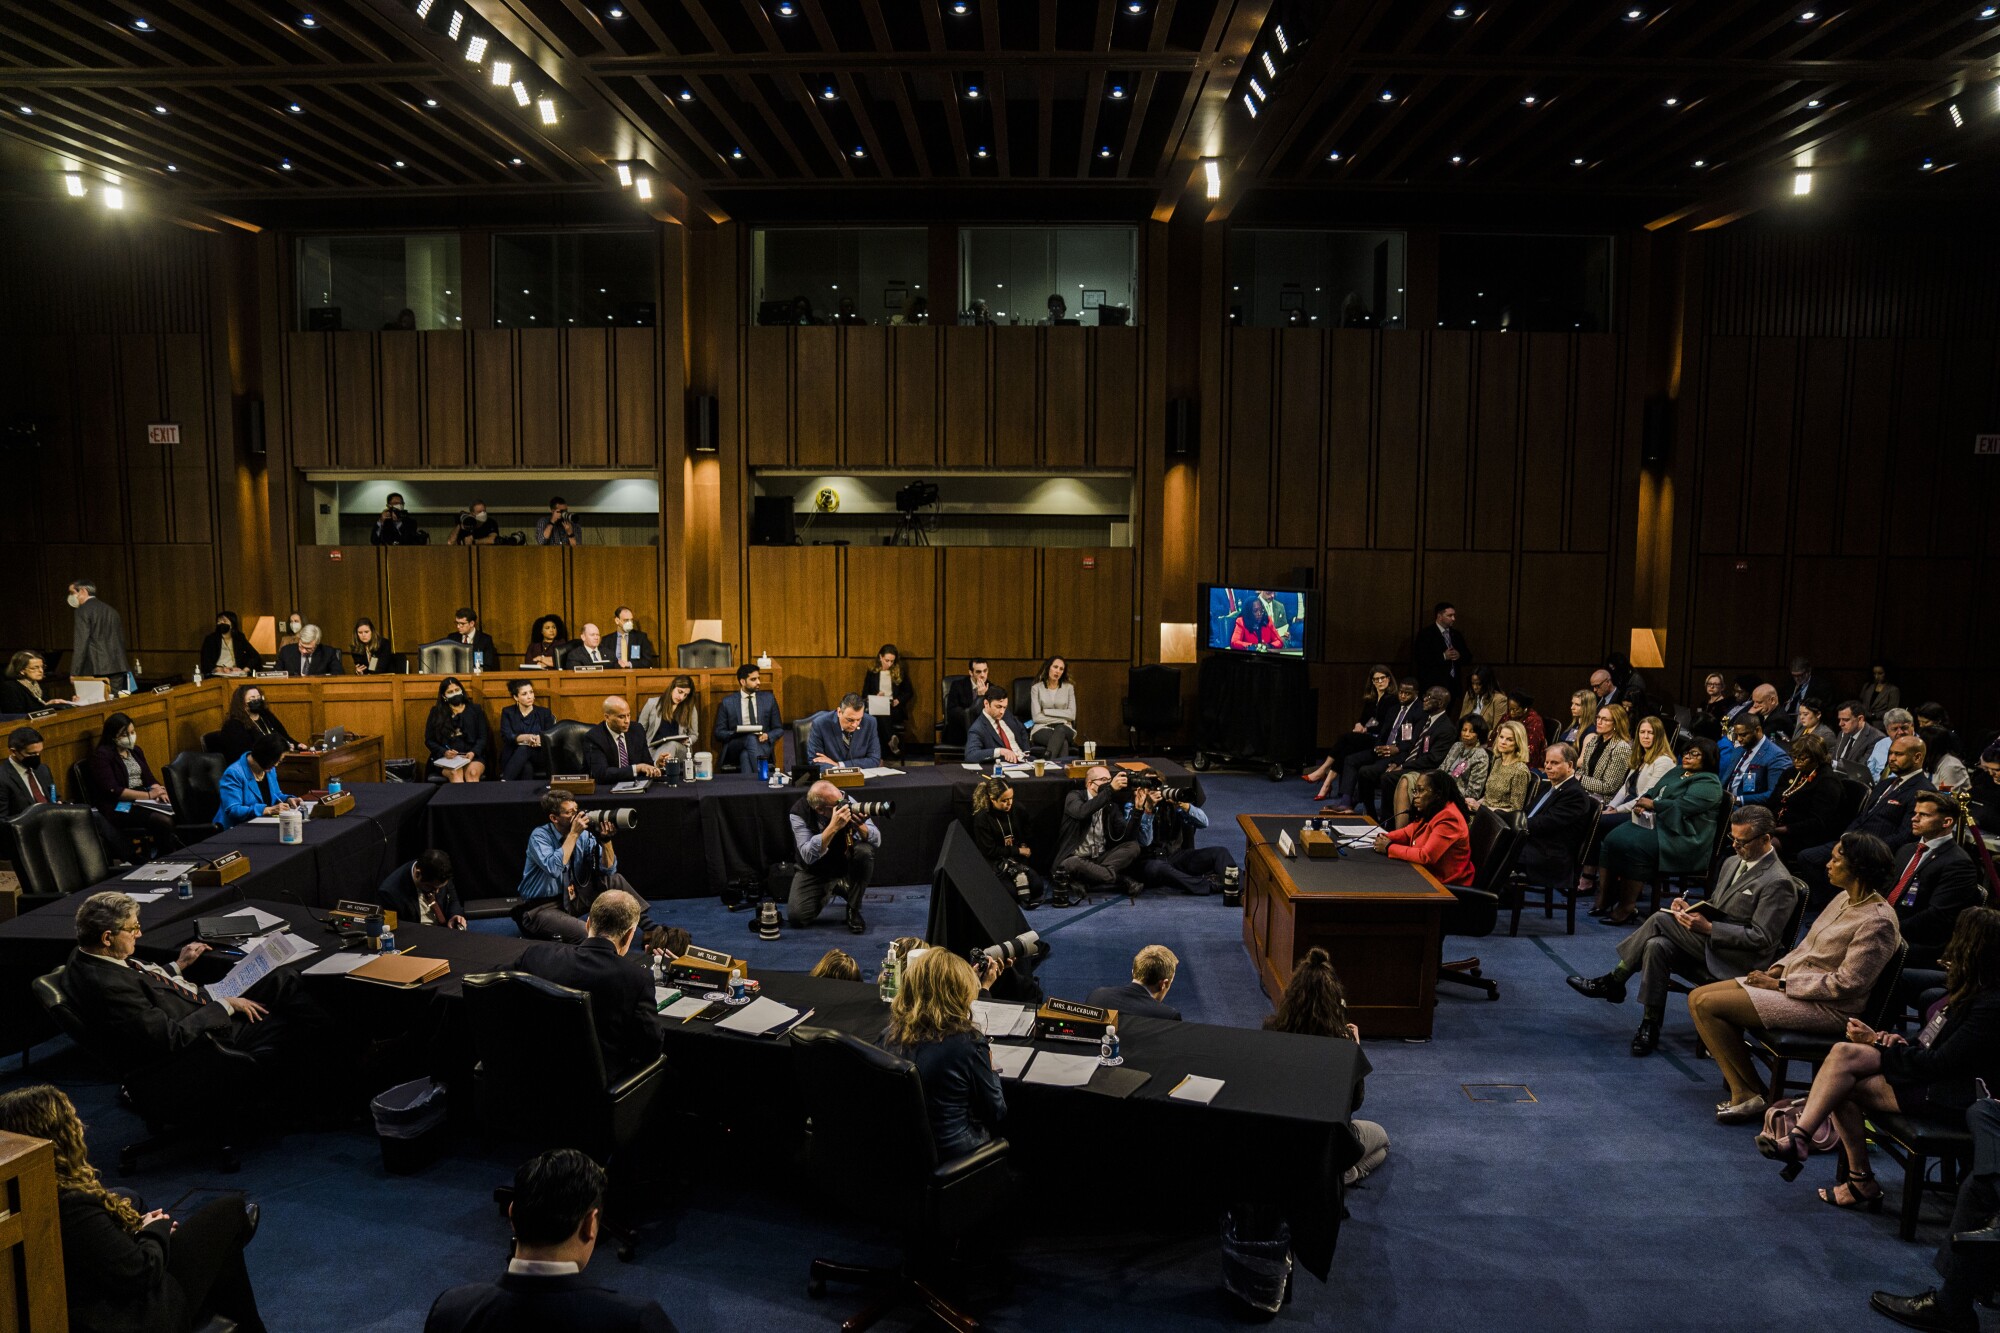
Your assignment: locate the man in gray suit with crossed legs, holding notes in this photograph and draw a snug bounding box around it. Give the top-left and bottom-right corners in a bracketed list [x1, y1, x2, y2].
[1568, 805, 1798, 1055]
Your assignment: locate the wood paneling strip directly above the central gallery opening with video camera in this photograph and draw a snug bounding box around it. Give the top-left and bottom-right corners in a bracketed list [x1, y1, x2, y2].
[742, 326, 1144, 468]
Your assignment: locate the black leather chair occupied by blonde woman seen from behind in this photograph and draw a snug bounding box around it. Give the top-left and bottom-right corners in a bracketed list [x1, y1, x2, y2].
[792, 1027, 1014, 1331]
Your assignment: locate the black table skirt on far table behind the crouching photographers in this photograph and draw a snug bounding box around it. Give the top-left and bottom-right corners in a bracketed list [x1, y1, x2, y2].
[428, 759, 1204, 899]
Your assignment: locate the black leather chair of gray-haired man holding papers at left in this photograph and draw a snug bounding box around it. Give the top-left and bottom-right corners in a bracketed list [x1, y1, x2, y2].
[32, 967, 264, 1175]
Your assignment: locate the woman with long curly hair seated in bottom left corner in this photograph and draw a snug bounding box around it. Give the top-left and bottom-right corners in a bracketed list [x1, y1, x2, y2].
[0, 1083, 264, 1333]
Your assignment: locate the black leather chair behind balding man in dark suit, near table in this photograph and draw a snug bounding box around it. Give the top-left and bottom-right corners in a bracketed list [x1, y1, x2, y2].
[466, 973, 666, 1263]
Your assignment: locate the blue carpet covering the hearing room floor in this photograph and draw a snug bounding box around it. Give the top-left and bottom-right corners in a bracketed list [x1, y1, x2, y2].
[0, 775, 1946, 1333]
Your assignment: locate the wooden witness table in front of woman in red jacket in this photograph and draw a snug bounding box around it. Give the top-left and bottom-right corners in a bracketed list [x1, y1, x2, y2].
[1236, 815, 1456, 1039]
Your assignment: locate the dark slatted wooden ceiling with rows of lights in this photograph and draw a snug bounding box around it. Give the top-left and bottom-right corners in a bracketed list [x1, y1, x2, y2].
[0, 0, 2000, 224]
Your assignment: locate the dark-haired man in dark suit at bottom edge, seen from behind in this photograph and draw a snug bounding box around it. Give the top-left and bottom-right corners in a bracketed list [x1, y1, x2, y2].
[424, 1149, 676, 1333]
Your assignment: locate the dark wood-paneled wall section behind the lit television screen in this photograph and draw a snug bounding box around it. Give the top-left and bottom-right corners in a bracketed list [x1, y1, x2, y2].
[1216, 328, 1636, 739]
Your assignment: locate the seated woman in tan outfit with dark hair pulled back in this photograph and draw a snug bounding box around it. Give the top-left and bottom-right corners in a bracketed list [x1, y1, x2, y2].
[1688, 833, 1902, 1125]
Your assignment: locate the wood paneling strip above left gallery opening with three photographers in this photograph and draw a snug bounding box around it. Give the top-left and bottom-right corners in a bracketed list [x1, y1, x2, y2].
[282, 328, 664, 470]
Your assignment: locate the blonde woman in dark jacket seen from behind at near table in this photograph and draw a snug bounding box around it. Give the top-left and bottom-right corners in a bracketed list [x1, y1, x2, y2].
[882, 949, 1006, 1161]
